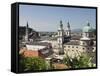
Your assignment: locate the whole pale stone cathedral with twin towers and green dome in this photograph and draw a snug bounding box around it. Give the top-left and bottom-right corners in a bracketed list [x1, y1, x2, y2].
[57, 21, 96, 61]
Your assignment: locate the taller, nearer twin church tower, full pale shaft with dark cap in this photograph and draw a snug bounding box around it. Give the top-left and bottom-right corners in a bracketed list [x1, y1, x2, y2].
[57, 21, 64, 54]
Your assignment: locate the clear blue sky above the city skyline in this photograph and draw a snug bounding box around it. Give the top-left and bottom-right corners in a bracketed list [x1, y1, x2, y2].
[19, 5, 96, 32]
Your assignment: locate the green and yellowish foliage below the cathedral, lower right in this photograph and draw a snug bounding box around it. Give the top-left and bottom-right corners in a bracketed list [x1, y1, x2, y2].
[64, 53, 94, 68]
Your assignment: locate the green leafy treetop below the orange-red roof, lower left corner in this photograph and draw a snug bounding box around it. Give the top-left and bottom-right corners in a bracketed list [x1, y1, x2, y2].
[20, 57, 47, 71]
